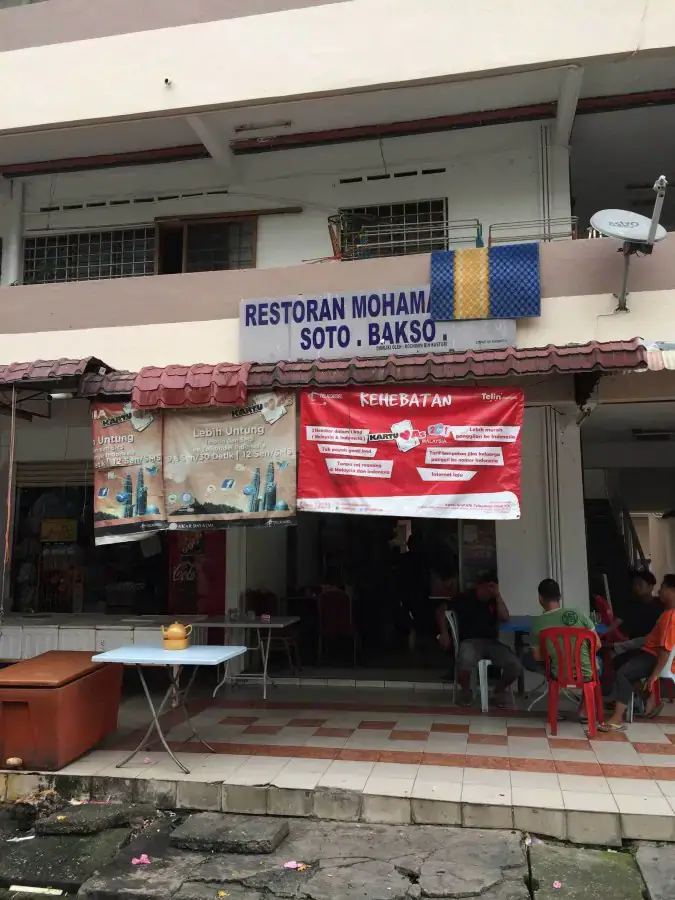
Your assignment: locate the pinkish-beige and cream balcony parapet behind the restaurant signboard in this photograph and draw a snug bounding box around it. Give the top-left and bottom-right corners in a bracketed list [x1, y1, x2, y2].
[0, 232, 675, 371]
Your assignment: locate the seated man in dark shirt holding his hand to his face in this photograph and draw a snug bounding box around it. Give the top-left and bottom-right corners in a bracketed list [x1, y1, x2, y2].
[438, 577, 521, 707]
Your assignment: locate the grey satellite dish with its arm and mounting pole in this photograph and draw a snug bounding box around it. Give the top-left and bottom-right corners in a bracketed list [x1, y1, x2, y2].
[591, 175, 668, 312]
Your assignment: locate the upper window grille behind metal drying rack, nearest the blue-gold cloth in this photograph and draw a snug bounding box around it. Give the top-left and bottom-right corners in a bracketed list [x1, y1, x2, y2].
[339, 198, 448, 259]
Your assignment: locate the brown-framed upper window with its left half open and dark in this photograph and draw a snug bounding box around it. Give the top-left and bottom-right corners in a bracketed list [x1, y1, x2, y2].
[185, 219, 255, 272]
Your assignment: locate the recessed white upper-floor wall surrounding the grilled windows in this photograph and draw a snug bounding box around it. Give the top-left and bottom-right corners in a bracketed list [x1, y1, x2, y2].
[17, 122, 548, 268]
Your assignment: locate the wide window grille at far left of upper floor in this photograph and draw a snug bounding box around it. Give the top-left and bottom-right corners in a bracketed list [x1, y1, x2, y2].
[23, 226, 155, 284]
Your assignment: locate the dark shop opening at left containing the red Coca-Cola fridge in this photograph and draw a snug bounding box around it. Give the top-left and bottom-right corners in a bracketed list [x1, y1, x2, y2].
[11, 474, 226, 616]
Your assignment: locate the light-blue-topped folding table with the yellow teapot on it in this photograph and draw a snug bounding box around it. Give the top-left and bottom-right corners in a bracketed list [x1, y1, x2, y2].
[92, 644, 246, 775]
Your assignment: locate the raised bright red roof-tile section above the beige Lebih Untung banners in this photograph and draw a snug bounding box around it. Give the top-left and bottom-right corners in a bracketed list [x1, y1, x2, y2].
[131, 363, 251, 409]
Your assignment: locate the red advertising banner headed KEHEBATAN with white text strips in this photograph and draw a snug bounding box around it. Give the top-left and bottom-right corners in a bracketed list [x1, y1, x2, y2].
[298, 385, 524, 519]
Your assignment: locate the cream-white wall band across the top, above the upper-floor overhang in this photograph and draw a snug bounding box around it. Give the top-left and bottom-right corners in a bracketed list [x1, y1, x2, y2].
[0, 0, 675, 131]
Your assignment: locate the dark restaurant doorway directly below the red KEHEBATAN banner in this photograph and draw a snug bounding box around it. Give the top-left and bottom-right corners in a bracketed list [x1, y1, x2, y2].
[287, 513, 497, 680]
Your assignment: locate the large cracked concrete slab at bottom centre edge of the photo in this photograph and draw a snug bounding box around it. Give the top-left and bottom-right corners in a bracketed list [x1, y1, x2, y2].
[186, 822, 529, 900]
